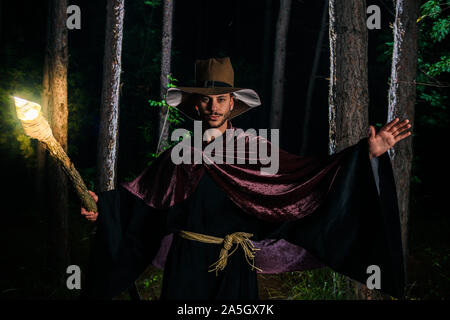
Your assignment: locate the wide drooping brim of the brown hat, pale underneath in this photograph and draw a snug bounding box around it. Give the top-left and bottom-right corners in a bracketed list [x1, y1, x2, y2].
[166, 87, 261, 120]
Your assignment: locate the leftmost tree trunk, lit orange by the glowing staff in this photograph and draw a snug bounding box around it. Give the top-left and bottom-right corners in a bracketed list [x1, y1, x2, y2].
[47, 0, 70, 284]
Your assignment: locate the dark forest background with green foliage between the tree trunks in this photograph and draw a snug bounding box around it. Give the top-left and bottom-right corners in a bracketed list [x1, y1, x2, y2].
[0, 0, 450, 299]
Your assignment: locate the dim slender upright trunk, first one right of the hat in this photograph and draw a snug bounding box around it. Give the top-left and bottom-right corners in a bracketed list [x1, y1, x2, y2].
[270, 0, 291, 129]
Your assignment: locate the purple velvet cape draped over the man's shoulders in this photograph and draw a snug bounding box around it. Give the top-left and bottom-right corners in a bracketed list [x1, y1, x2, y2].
[122, 122, 356, 274]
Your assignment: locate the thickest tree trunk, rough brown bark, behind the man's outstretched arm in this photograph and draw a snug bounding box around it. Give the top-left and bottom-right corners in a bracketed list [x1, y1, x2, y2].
[329, 0, 383, 300]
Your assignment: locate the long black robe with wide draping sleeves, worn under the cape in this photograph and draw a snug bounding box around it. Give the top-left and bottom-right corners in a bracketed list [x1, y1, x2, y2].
[83, 140, 404, 300]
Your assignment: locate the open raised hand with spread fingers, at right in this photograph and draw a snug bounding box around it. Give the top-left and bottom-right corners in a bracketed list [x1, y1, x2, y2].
[368, 118, 411, 158]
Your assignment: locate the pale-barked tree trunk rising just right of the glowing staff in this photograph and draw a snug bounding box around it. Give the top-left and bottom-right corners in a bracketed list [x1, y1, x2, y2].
[96, 0, 124, 192]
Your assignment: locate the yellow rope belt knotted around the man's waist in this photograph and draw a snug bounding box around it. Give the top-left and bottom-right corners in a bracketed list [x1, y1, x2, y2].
[179, 230, 262, 275]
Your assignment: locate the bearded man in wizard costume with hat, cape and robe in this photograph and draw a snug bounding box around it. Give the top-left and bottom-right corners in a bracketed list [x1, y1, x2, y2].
[81, 58, 410, 300]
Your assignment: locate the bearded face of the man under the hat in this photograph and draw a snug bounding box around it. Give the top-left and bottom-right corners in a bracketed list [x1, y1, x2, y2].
[197, 93, 234, 128]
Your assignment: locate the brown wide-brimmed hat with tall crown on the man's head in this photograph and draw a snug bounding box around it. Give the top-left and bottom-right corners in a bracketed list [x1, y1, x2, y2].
[166, 57, 261, 120]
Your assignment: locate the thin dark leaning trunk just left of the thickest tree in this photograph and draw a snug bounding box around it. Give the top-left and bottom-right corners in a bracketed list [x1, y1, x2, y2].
[300, 0, 328, 155]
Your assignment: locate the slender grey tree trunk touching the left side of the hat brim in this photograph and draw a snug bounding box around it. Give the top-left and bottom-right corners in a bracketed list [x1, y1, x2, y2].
[157, 0, 174, 152]
